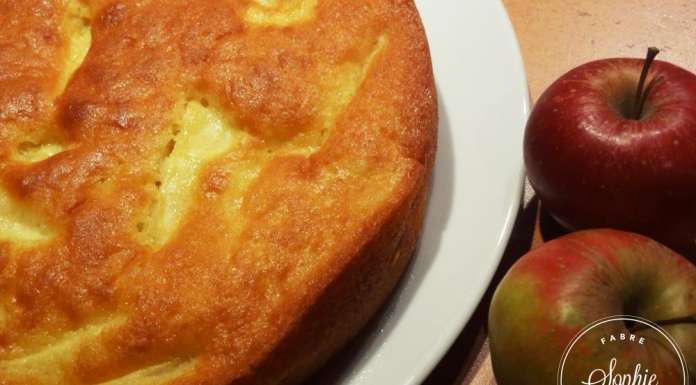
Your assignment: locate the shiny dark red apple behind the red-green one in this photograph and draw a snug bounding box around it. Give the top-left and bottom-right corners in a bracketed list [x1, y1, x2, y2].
[524, 59, 696, 256]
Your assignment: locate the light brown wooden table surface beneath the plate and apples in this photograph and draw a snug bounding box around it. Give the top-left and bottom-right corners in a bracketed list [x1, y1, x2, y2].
[424, 0, 696, 385]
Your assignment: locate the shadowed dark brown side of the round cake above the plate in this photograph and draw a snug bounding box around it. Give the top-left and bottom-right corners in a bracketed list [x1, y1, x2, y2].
[235, 166, 427, 385]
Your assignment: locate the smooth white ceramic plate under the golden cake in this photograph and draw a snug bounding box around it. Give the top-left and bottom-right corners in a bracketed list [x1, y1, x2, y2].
[324, 0, 529, 385]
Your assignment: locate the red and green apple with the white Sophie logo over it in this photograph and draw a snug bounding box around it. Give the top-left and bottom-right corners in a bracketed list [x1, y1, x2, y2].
[488, 230, 696, 385]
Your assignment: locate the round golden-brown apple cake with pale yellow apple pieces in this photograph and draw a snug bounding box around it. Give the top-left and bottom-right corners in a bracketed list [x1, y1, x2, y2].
[0, 0, 437, 385]
